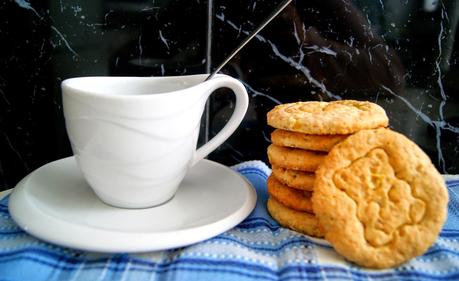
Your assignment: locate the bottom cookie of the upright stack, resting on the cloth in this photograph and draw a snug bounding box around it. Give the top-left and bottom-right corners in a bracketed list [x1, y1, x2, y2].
[268, 197, 324, 238]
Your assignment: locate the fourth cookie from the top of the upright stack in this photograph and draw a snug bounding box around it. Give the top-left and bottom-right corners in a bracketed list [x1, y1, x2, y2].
[272, 165, 316, 191]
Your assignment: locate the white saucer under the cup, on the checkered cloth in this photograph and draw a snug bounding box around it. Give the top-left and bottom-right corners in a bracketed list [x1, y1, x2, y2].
[9, 157, 256, 252]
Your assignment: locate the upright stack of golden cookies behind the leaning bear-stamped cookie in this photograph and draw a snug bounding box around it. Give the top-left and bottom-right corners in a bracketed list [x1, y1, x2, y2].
[267, 100, 388, 237]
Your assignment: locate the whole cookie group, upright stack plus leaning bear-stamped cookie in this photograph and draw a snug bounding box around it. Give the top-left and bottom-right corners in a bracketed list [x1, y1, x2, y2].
[268, 100, 448, 268]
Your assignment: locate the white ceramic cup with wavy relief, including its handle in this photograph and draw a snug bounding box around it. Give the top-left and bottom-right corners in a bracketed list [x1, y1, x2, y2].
[62, 74, 248, 208]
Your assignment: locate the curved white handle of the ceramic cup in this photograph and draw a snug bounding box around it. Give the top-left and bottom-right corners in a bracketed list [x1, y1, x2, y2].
[191, 75, 249, 166]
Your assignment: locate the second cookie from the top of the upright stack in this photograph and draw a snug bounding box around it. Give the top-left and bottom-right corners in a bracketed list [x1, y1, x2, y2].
[271, 129, 348, 152]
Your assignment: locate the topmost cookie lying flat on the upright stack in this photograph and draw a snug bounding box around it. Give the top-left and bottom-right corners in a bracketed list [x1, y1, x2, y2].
[267, 100, 389, 135]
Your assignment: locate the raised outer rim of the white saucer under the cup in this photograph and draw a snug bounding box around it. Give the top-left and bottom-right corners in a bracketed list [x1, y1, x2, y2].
[8, 156, 257, 253]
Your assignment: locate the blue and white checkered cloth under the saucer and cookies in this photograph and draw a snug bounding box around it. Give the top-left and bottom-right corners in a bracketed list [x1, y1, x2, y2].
[0, 161, 459, 281]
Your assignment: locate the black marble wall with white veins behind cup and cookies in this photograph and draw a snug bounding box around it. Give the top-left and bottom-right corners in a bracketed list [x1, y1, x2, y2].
[0, 0, 459, 190]
